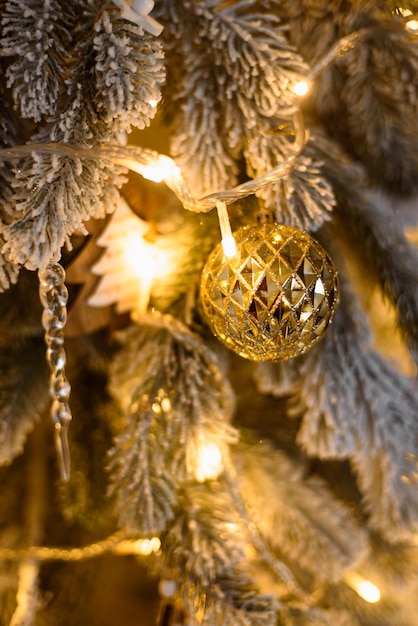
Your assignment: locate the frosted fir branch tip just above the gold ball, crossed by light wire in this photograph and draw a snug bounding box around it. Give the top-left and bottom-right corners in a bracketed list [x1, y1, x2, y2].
[245, 130, 335, 231]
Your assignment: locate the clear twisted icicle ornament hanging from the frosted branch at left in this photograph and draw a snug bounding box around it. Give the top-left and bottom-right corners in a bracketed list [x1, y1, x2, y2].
[38, 263, 72, 480]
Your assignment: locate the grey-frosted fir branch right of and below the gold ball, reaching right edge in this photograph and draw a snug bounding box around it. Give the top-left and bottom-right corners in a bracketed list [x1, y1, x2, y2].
[298, 296, 418, 540]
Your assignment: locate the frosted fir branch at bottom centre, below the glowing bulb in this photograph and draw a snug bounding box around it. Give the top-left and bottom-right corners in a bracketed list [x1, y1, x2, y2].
[163, 482, 278, 626]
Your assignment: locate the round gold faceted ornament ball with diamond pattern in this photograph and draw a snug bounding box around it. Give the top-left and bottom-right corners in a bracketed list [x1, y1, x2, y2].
[201, 223, 338, 361]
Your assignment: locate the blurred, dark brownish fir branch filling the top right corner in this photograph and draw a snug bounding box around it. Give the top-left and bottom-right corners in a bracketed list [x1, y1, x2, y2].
[282, 0, 418, 195]
